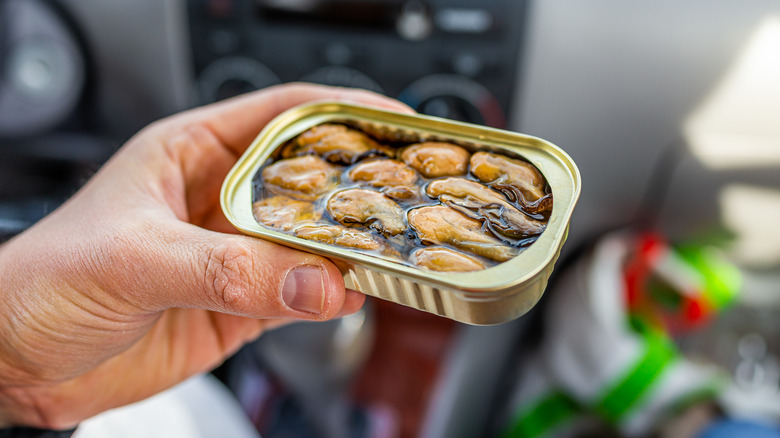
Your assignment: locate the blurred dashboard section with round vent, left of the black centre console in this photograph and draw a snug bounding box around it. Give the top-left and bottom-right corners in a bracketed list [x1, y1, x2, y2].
[0, 0, 192, 241]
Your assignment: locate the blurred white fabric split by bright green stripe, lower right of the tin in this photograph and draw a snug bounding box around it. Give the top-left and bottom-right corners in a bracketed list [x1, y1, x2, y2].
[542, 234, 724, 436]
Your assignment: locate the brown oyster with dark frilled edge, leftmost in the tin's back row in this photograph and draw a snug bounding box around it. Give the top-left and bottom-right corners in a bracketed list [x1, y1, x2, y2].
[282, 123, 394, 164]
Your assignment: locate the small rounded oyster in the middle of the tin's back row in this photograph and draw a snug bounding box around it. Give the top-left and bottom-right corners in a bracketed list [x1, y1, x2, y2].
[401, 142, 471, 178]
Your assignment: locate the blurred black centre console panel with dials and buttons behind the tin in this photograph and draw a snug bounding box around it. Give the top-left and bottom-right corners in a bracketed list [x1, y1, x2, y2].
[188, 0, 524, 127]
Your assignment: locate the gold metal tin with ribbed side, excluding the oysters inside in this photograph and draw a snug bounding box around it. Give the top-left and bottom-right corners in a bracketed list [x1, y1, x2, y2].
[220, 103, 580, 325]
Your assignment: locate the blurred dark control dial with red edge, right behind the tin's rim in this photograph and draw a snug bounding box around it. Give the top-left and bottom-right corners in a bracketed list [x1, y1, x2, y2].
[398, 74, 506, 128]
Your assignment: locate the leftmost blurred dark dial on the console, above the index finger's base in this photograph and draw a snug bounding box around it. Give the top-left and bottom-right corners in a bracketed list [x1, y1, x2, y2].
[197, 57, 281, 103]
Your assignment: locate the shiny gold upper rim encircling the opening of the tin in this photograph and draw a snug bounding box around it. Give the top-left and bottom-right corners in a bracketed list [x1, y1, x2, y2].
[220, 102, 581, 298]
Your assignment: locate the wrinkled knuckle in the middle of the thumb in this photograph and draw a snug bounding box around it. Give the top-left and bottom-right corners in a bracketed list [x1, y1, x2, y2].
[204, 239, 255, 312]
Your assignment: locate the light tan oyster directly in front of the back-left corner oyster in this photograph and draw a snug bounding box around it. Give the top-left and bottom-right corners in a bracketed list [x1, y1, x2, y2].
[262, 155, 339, 200]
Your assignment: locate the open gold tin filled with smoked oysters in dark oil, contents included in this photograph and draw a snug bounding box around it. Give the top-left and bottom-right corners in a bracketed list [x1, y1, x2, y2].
[220, 103, 580, 325]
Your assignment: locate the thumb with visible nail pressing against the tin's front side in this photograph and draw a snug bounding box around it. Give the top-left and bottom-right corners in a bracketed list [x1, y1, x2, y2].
[131, 224, 363, 320]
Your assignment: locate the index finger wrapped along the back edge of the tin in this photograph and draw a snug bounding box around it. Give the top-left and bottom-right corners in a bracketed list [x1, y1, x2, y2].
[189, 83, 414, 155]
